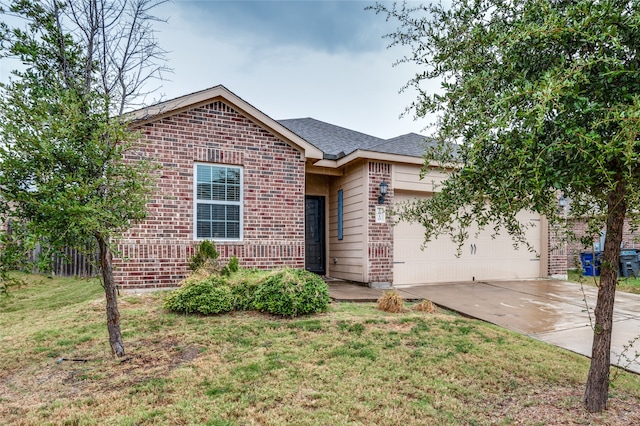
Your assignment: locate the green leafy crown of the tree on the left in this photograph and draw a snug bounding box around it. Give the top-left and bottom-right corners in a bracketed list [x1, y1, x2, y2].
[0, 1, 159, 262]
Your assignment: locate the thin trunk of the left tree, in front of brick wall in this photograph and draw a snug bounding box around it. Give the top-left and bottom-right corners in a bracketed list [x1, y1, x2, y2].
[96, 235, 124, 357]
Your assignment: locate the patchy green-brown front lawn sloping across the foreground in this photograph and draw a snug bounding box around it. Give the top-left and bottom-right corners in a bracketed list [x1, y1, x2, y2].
[0, 277, 640, 425]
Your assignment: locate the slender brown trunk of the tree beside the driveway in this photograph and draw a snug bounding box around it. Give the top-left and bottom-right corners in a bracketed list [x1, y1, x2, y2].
[584, 181, 627, 413]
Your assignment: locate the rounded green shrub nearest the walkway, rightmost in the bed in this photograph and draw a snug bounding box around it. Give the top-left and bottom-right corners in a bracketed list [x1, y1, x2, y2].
[254, 268, 329, 317]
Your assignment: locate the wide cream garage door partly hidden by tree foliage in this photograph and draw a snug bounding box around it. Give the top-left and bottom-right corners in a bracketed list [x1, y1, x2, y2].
[393, 192, 541, 285]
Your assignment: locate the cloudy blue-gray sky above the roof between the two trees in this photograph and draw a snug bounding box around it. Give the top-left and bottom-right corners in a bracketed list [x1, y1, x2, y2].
[156, 0, 432, 138]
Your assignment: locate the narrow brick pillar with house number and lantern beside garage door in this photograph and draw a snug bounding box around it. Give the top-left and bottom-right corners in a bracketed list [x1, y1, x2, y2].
[367, 162, 393, 285]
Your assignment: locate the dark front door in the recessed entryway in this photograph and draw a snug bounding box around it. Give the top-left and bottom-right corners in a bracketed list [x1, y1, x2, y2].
[304, 195, 326, 275]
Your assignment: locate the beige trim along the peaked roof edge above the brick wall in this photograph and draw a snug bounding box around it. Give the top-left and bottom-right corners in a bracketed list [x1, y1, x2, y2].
[128, 85, 323, 160]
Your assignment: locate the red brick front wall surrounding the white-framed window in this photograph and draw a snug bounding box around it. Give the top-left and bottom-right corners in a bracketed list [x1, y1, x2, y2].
[115, 101, 305, 288]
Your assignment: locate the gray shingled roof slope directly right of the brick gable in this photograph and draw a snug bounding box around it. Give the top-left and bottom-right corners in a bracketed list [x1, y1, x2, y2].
[278, 118, 385, 159]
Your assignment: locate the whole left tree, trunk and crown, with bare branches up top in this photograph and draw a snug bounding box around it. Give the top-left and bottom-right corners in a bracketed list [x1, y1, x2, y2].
[0, 0, 164, 356]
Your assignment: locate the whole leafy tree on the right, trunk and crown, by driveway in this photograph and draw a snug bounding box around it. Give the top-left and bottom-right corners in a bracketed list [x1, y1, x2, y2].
[373, 0, 640, 412]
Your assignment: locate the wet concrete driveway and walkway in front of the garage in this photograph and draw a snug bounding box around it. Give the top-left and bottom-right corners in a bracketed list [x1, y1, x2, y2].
[328, 280, 640, 373]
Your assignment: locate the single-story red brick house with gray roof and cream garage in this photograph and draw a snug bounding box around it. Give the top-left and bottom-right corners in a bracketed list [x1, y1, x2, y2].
[115, 86, 566, 288]
